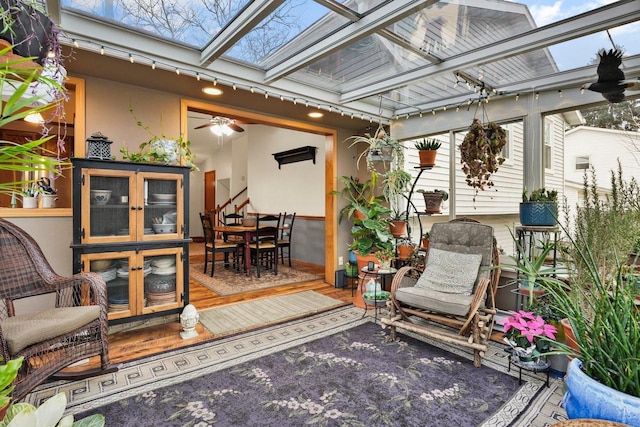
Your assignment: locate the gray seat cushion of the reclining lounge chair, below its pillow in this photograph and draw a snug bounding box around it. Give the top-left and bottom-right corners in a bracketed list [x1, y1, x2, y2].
[396, 286, 473, 316]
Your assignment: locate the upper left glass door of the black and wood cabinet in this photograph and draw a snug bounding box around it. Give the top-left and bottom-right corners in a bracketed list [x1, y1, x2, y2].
[82, 170, 136, 243]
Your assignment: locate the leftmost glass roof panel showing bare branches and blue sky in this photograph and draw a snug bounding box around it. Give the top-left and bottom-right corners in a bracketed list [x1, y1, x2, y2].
[61, 0, 250, 49]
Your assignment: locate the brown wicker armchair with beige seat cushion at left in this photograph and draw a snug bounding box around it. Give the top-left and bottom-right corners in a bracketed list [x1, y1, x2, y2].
[0, 219, 117, 400]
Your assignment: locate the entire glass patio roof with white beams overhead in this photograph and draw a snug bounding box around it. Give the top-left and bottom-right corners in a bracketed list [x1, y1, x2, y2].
[46, 0, 640, 125]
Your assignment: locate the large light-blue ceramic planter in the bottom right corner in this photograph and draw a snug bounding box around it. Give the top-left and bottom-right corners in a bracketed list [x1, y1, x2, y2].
[562, 359, 640, 426]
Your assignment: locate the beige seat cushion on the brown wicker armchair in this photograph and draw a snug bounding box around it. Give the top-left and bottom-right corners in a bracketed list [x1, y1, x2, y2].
[0, 305, 100, 355]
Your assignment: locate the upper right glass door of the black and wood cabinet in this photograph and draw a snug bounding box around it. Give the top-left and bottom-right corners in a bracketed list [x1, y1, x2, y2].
[138, 173, 184, 240]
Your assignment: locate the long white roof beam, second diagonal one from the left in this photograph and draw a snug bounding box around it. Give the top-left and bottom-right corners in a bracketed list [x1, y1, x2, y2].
[265, 0, 440, 83]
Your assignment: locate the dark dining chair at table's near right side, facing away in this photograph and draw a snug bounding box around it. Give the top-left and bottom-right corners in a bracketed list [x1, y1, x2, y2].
[251, 214, 281, 277]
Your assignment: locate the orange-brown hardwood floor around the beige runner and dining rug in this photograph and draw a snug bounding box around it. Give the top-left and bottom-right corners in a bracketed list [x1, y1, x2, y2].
[103, 244, 353, 367]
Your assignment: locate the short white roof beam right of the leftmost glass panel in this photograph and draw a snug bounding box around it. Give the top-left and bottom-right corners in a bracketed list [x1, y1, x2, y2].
[200, 0, 284, 67]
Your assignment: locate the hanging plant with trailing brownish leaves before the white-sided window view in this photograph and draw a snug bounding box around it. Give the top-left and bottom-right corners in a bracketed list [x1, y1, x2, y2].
[460, 119, 507, 202]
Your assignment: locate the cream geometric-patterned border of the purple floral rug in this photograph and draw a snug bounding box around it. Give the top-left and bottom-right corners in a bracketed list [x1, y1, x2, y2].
[25, 306, 559, 427]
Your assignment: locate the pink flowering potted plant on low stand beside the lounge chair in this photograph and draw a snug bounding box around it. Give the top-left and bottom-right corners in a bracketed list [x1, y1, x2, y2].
[503, 310, 558, 358]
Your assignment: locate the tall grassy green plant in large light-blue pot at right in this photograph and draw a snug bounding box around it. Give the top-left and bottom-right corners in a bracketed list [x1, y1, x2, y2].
[542, 169, 640, 425]
